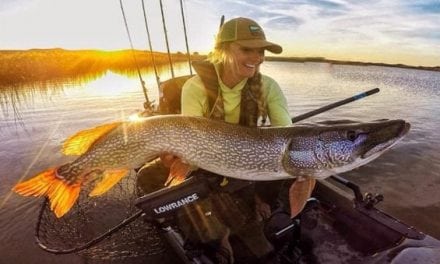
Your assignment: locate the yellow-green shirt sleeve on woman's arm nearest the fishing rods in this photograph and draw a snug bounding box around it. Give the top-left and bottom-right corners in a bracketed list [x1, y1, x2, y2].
[181, 76, 207, 116]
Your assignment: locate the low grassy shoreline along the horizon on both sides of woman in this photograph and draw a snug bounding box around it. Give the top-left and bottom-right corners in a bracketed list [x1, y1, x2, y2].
[0, 48, 440, 86]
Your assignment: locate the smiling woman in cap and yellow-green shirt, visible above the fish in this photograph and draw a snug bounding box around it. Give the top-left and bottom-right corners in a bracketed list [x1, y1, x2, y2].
[181, 17, 292, 126]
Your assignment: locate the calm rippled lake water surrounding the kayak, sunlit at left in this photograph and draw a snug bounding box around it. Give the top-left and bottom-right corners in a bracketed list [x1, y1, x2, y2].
[0, 62, 440, 264]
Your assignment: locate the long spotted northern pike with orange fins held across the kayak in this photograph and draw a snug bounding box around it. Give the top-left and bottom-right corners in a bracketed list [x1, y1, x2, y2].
[13, 115, 410, 217]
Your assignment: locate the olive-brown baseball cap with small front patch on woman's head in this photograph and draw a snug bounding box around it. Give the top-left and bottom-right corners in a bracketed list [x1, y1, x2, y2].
[216, 17, 283, 54]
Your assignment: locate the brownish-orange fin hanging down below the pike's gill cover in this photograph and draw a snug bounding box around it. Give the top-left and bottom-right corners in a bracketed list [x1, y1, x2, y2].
[289, 177, 316, 218]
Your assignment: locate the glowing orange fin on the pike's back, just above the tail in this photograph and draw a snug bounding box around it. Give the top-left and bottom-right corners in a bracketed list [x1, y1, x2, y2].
[62, 122, 121, 155]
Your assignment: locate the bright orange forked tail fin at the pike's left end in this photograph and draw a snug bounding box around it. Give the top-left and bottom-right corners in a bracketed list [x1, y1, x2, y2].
[12, 168, 81, 218]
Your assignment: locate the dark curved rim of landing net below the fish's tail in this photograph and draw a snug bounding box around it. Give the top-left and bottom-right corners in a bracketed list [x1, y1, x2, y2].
[35, 198, 143, 254]
